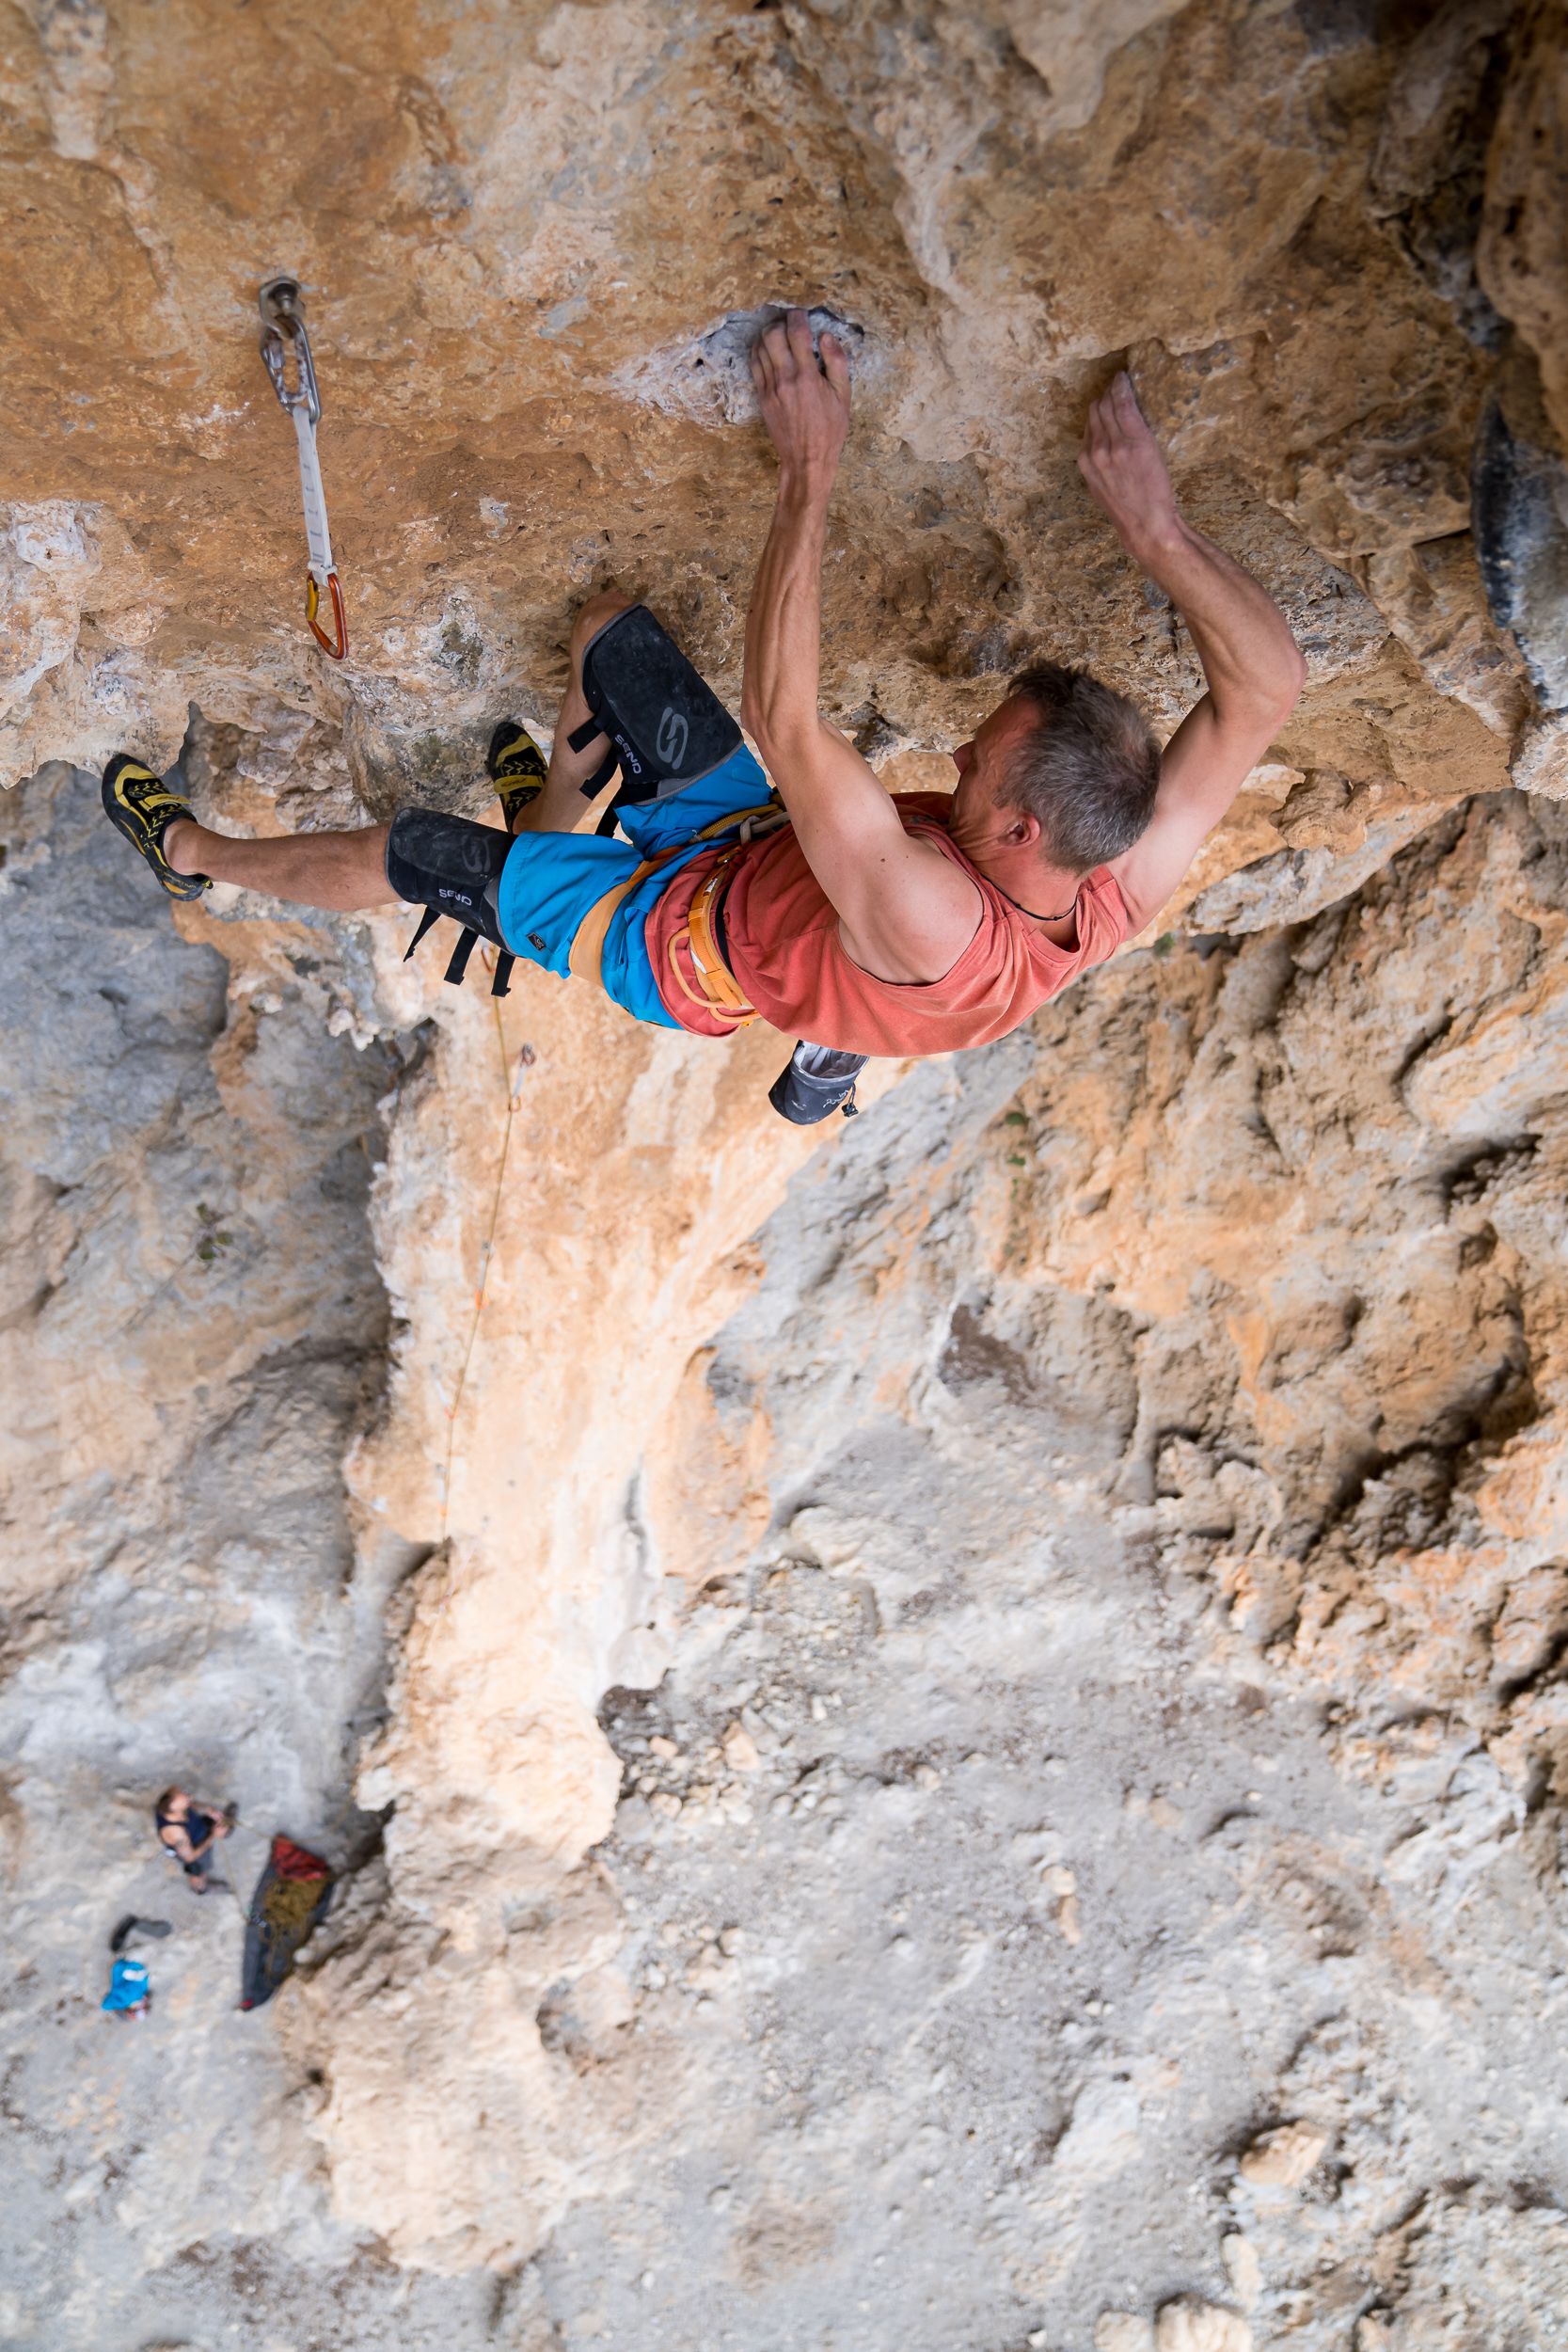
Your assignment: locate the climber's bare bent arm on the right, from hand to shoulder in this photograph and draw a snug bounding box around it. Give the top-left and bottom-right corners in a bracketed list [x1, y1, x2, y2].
[1079, 374, 1307, 931]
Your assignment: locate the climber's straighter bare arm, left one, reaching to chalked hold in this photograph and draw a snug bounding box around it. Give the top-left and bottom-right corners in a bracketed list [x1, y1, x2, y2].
[740, 310, 980, 983]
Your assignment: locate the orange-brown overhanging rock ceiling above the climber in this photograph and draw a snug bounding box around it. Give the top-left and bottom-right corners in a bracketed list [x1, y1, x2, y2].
[0, 0, 1561, 870]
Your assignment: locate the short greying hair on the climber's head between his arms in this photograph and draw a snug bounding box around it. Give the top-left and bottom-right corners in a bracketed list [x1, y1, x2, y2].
[1002, 661, 1159, 875]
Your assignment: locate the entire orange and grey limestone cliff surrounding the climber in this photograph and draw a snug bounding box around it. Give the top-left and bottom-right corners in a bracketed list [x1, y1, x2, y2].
[0, 0, 1568, 2352]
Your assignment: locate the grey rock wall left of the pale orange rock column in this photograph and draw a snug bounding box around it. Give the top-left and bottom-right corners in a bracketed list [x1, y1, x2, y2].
[0, 770, 489, 2352]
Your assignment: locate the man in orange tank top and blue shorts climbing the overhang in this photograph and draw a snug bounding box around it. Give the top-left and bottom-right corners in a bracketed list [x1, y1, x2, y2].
[103, 310, 1305, 1115]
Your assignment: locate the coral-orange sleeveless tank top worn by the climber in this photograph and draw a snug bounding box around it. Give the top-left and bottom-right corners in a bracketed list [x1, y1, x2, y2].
[646, 793, 1129, 1058]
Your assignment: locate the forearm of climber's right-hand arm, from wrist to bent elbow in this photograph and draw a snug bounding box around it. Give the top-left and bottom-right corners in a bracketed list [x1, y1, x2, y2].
[1126, 513, 1307, 729]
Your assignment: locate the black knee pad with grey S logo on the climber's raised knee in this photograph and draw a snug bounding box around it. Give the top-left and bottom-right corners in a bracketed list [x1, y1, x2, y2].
[566, 605, 740, 803]
